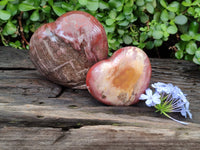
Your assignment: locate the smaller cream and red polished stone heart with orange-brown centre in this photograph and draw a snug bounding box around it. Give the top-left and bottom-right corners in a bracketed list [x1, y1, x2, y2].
[86, 47, 151, 105]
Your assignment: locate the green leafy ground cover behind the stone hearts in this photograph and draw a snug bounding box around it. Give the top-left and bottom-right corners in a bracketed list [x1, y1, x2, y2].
[0, 0, 200, 64]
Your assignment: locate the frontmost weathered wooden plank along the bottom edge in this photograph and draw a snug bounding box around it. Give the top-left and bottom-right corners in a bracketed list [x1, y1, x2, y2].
[0, 125, 200, 150]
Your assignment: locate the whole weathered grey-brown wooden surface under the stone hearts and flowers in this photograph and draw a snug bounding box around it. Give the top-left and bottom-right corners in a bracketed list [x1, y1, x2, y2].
[0, 47, 200, 150]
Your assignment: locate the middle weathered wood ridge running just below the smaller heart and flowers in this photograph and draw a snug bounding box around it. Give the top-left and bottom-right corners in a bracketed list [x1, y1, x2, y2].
[0, 94, 195, 128]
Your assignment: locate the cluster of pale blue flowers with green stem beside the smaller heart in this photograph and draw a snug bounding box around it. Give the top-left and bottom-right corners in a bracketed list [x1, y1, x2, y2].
[139, 82, 192, 125]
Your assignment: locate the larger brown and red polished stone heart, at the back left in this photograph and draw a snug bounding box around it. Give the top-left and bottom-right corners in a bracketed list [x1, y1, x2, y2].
[30, 11, 108, 88]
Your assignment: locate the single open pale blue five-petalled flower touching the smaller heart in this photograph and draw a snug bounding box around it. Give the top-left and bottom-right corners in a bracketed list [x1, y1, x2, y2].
[140, 88, 161, 107]
